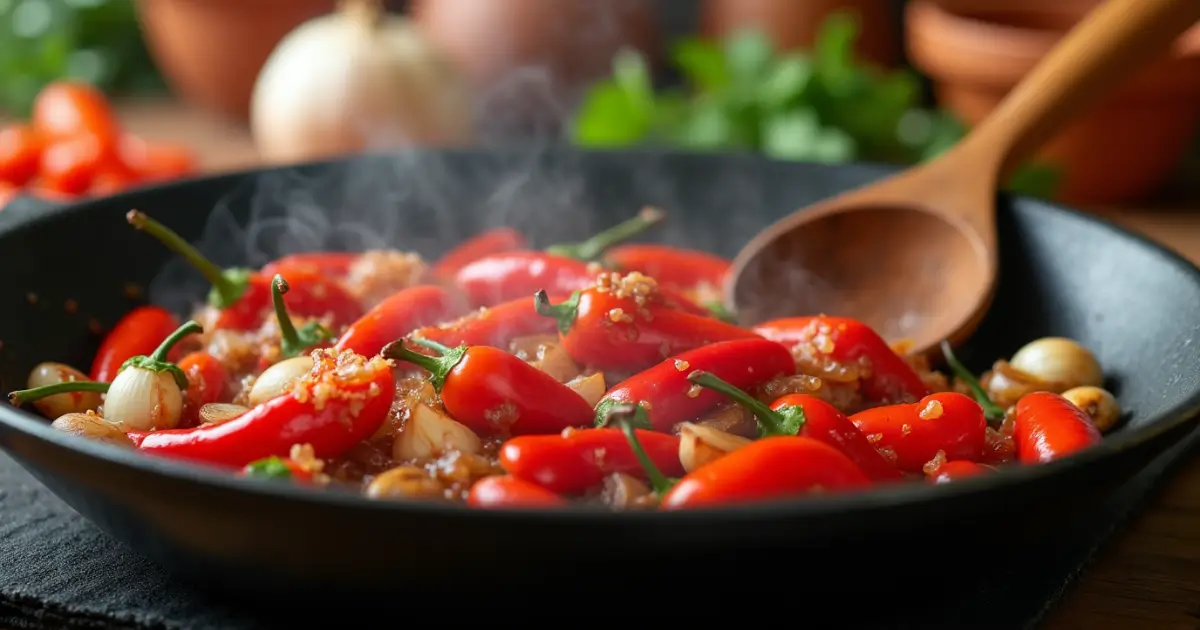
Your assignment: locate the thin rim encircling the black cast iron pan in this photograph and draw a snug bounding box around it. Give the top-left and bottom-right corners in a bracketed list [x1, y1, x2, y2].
[0, 146, 1200, 524]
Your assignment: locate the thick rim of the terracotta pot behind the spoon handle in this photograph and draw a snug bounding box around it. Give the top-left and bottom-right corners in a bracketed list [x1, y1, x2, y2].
[905, 0, 1200, 95]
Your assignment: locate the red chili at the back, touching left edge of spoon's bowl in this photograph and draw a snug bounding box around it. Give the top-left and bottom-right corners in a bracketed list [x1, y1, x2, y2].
[604, 242, 730, 290]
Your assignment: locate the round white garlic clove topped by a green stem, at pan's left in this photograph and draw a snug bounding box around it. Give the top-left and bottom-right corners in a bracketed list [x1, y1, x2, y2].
[104, 367, 184, 431]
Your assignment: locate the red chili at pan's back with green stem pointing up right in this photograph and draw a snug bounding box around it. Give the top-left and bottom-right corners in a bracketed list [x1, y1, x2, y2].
[454, 209, 664, 306]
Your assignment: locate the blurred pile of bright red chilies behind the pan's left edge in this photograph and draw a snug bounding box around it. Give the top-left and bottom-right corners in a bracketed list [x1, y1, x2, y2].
[0, 82, 196, 209]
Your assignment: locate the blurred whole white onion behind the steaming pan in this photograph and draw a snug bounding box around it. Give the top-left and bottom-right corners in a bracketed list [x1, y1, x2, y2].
[251, 0, 470, 162]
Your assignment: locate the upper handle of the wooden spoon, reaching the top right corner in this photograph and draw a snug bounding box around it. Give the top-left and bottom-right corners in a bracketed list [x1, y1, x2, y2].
[964, 0, 1200, 181]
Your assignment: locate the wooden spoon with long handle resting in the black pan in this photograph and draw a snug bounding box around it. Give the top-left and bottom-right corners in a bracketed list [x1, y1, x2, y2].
[725, 0, 1200, 353]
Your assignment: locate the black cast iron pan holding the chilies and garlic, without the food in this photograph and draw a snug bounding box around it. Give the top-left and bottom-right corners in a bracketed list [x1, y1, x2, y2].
[0, 149, 1200, 604]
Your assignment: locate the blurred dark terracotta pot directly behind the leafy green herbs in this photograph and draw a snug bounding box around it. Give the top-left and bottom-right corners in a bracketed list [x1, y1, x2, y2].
[700, 0, 901, 67]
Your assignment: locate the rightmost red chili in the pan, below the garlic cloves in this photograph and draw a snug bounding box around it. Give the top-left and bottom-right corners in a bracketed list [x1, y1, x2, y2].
[1013, 391, 1103, 463]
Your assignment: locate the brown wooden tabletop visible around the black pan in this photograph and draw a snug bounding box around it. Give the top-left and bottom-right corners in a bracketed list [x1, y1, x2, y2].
[114, 102, 1200, 630]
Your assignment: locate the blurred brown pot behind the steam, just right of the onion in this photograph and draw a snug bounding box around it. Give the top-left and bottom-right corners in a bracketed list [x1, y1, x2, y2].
[412, 0, 660, 130]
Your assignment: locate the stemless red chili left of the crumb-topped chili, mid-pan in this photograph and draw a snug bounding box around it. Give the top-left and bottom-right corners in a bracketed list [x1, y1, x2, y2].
[410, 291, 563, 350]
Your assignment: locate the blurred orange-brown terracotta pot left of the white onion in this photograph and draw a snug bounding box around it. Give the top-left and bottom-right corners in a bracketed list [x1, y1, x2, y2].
[137, 0, 336, 120]
